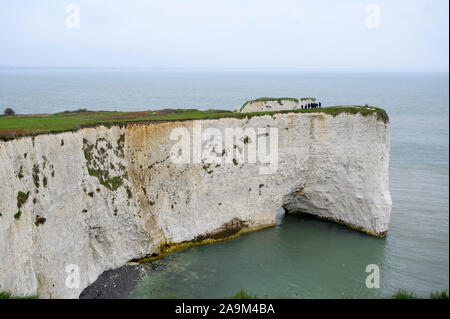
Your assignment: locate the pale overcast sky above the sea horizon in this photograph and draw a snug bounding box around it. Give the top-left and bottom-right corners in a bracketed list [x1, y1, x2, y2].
[0, 0, 449, 72]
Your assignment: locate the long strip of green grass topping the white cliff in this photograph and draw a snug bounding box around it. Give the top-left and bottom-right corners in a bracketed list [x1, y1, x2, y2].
[0, 105, 389, 140]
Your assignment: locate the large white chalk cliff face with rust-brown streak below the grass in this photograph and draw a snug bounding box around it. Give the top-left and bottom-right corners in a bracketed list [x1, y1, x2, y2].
[0, 112, 391, 298]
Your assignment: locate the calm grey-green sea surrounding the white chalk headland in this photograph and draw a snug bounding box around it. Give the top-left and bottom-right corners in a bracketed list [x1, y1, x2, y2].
[0, 68, 449, 298]
